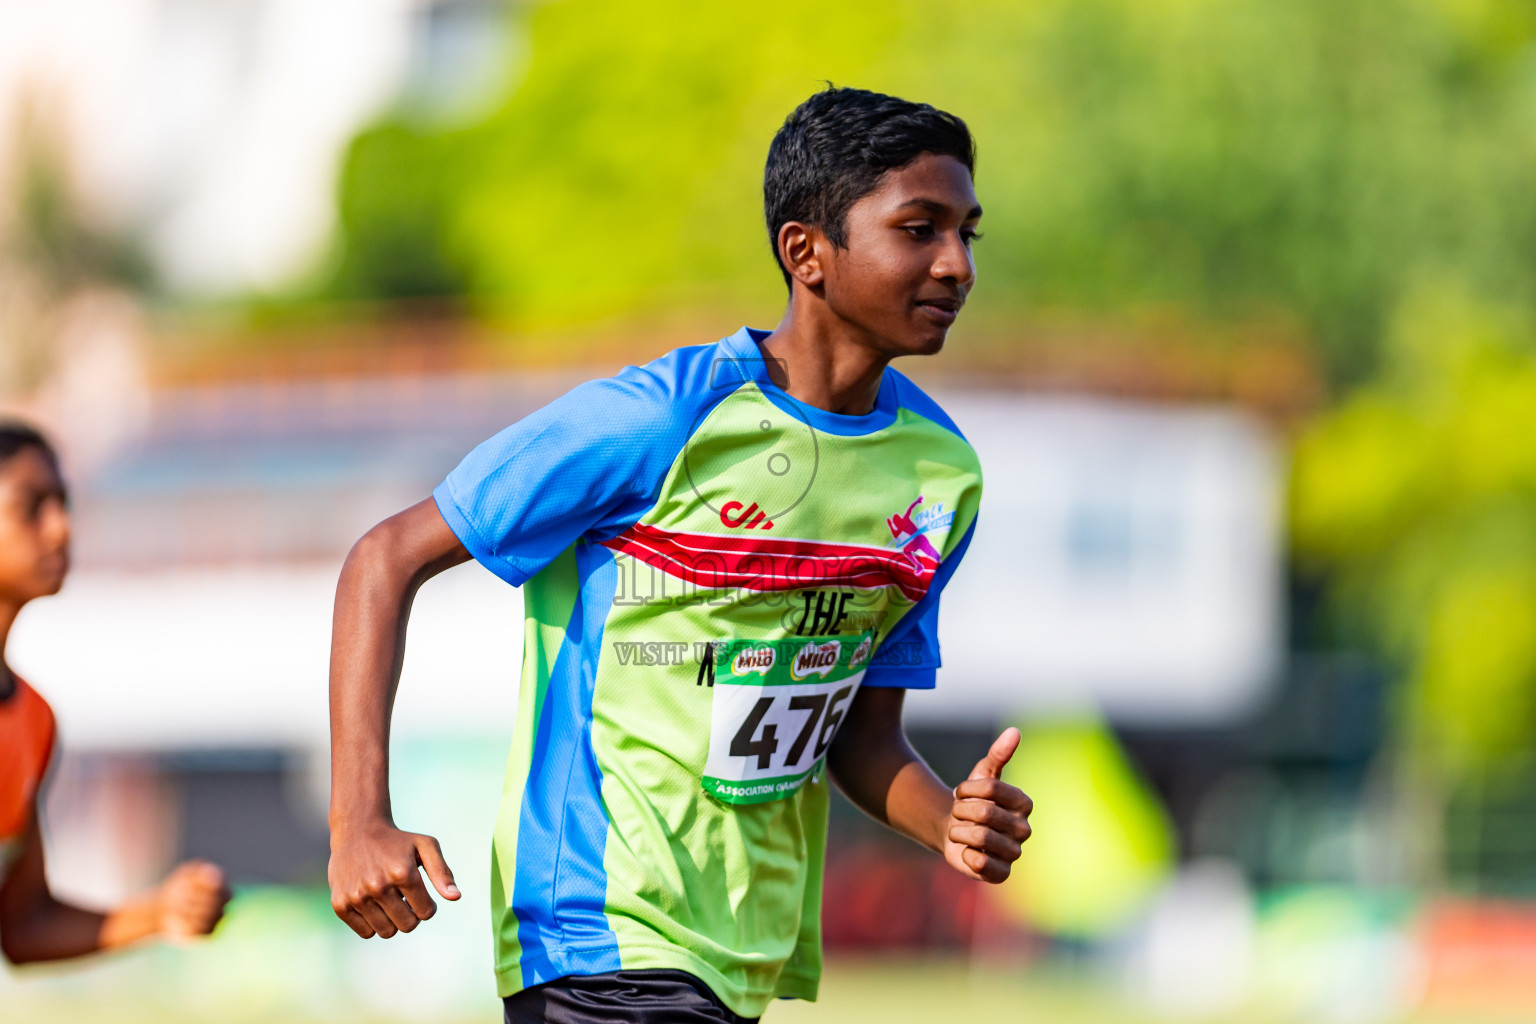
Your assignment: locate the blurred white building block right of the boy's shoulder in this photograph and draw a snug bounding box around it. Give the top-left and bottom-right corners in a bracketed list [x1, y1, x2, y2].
[933, 395, 1284, 728]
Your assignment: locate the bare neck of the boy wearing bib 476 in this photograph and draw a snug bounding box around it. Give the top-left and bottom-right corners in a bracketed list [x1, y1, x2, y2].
[762, 301, 891, 416]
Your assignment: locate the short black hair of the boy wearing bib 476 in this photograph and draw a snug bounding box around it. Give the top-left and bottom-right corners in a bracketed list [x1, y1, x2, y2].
[763, 84, 975, 284]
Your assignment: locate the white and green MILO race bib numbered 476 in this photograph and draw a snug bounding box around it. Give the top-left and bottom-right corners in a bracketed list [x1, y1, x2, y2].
[703, 633, 874, 803]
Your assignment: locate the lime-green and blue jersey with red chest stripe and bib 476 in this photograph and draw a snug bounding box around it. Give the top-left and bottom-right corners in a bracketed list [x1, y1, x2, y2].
[433, 329, 982, 1016]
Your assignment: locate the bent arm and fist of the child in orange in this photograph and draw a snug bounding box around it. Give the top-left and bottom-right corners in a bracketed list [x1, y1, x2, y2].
[0, 814, 229, 964]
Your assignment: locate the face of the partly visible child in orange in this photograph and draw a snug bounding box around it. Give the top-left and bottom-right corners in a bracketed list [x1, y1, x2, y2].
[0, 448, 69, 603]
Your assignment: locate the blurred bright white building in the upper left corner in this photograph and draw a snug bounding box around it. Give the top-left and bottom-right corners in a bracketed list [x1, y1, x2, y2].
[0, 0, 516, 295]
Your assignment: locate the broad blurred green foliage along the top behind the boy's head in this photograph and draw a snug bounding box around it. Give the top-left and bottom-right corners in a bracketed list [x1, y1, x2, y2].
[338, 0, 1536, 379]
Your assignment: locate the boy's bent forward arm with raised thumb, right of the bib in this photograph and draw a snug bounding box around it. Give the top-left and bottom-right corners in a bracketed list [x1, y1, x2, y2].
[828, 686, 1034, 884]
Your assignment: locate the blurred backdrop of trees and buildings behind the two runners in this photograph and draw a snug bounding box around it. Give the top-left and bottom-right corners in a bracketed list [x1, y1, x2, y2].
[0, 0, 1536, 1024]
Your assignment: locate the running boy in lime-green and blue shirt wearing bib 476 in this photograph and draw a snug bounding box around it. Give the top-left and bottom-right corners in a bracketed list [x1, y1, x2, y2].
[330, 89, 1031, 1024]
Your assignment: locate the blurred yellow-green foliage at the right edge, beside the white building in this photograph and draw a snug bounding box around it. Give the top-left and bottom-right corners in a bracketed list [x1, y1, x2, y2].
[1293, 293, 1536, 774]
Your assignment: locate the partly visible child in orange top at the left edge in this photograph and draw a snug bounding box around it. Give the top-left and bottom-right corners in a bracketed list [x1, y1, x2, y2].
[0, 424, 229, 964]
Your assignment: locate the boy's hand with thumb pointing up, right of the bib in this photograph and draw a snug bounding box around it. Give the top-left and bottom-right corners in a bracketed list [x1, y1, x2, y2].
[945, 728, 1035, 884]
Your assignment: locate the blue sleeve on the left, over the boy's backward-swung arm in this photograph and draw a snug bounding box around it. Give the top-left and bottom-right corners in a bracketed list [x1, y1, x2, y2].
[432, 348, 723, 586]
